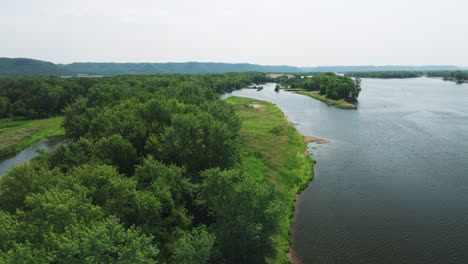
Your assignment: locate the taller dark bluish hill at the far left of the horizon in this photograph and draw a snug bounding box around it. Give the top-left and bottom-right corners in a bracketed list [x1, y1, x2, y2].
[0, 58, 72, 76]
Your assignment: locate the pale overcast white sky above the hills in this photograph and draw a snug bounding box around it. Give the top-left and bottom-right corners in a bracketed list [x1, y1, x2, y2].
[0, 0, 468, 66]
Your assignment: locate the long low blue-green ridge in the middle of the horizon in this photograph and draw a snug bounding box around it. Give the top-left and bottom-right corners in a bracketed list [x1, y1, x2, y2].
[62, 62, 302, 75]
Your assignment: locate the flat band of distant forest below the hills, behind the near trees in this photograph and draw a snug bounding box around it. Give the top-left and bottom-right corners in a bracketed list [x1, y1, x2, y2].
[0, 73, 265, 118]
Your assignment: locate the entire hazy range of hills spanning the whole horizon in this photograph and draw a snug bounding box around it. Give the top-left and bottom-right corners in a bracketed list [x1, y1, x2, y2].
[0, 58, 464, 76]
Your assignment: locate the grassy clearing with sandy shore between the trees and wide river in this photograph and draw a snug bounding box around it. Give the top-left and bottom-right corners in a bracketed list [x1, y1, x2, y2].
[226, 97, 313, 263]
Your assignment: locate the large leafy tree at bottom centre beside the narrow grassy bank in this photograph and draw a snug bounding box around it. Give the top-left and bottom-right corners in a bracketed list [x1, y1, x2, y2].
[199, 169, 284, 263]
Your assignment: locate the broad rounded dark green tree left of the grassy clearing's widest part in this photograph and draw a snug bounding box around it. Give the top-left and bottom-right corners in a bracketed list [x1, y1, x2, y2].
[153, 111, 239, 171]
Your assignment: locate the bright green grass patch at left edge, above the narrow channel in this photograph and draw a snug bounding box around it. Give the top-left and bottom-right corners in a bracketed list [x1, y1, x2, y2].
[0, 117, 65, 158]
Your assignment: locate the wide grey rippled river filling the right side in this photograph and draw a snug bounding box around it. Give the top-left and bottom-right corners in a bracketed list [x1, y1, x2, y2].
[222, 78, 468, 264]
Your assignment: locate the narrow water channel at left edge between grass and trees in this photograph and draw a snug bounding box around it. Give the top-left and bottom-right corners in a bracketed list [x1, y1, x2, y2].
[0, 138, 64, 176]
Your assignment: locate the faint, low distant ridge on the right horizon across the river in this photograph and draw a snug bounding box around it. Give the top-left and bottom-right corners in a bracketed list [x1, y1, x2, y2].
[301, 65, 460, 72]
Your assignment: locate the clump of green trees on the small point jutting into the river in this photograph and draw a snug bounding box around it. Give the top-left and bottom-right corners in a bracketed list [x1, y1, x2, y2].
[277, 72, 361, 102]
